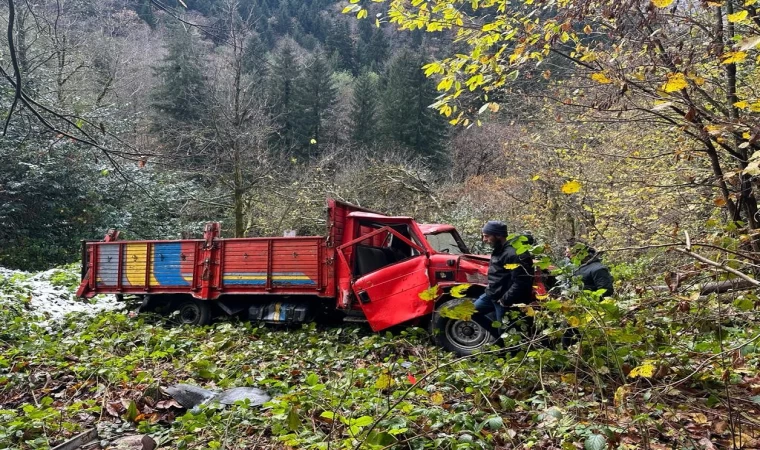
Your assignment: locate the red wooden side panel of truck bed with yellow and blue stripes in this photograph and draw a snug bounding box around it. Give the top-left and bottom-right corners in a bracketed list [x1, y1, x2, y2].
[77, 237, 329, 299]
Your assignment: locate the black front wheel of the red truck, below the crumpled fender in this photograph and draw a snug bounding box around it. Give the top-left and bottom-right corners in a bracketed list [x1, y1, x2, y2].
[430, 299, 497, 356]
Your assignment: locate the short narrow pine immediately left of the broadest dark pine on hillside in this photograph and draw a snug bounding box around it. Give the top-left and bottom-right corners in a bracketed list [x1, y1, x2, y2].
[351, 72, 378, 146]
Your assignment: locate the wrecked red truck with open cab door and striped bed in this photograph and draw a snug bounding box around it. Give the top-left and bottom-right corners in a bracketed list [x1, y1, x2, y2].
[77, 199, 528, 354]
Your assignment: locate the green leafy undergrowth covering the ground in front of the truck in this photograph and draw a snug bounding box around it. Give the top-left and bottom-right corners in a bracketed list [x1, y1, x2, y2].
[0, 270, 760, 450]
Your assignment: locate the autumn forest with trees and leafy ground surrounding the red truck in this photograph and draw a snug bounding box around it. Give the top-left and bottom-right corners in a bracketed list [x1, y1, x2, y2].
[0, 0, 760, 450]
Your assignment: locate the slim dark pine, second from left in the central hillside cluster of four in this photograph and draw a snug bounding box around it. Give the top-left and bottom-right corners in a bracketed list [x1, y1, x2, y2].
[297, 54, 338, 155]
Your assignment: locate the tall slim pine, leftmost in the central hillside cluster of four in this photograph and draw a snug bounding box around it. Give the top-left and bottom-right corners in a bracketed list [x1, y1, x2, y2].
[269, 43, 299, 150]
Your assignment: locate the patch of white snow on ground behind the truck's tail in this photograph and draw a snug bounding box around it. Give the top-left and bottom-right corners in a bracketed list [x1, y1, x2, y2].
[0, 267, 124, 325]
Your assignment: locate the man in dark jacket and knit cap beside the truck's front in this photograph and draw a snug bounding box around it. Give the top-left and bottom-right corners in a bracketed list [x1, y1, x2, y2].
[473, 220, 534, 335]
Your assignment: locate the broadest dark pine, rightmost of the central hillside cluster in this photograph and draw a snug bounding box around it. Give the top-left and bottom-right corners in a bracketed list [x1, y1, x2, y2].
[381, 50, 446, 157]
